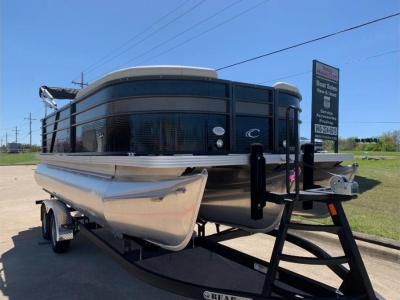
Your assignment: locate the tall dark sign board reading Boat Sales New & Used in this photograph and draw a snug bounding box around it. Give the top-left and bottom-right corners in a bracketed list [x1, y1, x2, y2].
[311, 60, 339, 143]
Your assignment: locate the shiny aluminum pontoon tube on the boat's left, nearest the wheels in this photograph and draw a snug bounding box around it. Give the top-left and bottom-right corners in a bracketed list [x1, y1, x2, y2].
[35, 163, 208, 251]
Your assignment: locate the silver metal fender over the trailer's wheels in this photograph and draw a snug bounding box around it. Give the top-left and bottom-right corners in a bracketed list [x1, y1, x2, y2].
[42, 200, 74, 242]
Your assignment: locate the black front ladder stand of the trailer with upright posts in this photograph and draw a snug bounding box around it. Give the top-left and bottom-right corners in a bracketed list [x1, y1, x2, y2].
[251, 106, 379, 299]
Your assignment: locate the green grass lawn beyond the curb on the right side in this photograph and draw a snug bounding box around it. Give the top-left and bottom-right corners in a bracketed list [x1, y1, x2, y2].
[300, 152, 400, 240]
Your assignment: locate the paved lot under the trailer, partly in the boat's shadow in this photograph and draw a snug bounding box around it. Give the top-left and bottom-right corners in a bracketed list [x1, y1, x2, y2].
[0, 165, 400, 300]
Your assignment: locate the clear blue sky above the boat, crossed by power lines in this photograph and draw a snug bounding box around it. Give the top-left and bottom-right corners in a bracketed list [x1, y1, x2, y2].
[0, 0, 400, 145]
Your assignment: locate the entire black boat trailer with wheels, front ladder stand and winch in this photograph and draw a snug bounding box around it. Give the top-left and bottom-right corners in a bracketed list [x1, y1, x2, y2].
[36, 106, 384, 300]
